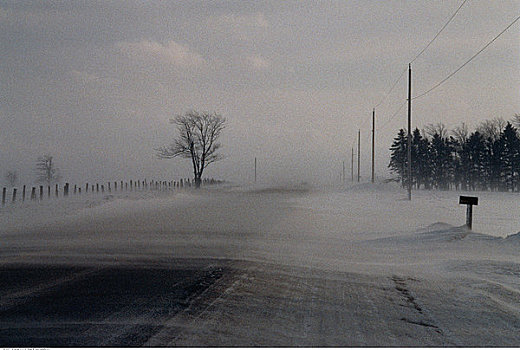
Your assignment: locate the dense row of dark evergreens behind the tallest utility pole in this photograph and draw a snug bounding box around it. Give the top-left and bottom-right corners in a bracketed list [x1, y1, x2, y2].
[388, 114, 520, 192]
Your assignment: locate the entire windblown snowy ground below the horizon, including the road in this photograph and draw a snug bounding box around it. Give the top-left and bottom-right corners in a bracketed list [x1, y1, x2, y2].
[0, 184, 520, 346]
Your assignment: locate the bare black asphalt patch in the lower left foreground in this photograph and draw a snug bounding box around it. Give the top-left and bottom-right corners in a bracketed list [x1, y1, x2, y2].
[0, 264, 231, 347]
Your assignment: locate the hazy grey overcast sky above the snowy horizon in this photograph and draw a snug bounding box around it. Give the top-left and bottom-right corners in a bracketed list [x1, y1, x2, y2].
[0, 0, 520, 183]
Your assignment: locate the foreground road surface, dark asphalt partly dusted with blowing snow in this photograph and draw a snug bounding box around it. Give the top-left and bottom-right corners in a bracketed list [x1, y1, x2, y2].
[0, 259, 519, 347]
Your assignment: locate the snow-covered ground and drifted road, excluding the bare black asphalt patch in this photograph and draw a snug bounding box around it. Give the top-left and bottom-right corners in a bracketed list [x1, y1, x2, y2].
[0, 184, 520, 345]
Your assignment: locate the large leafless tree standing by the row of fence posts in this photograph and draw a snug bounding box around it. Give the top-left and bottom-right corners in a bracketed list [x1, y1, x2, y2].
[155, 111, 226, 187]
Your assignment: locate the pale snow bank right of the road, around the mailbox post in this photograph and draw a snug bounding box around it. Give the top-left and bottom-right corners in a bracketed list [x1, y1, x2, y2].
[295, 183, 520, 237]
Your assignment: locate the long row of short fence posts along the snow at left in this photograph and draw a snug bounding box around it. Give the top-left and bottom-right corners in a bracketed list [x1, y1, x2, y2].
[2, 178, 223, 206]
